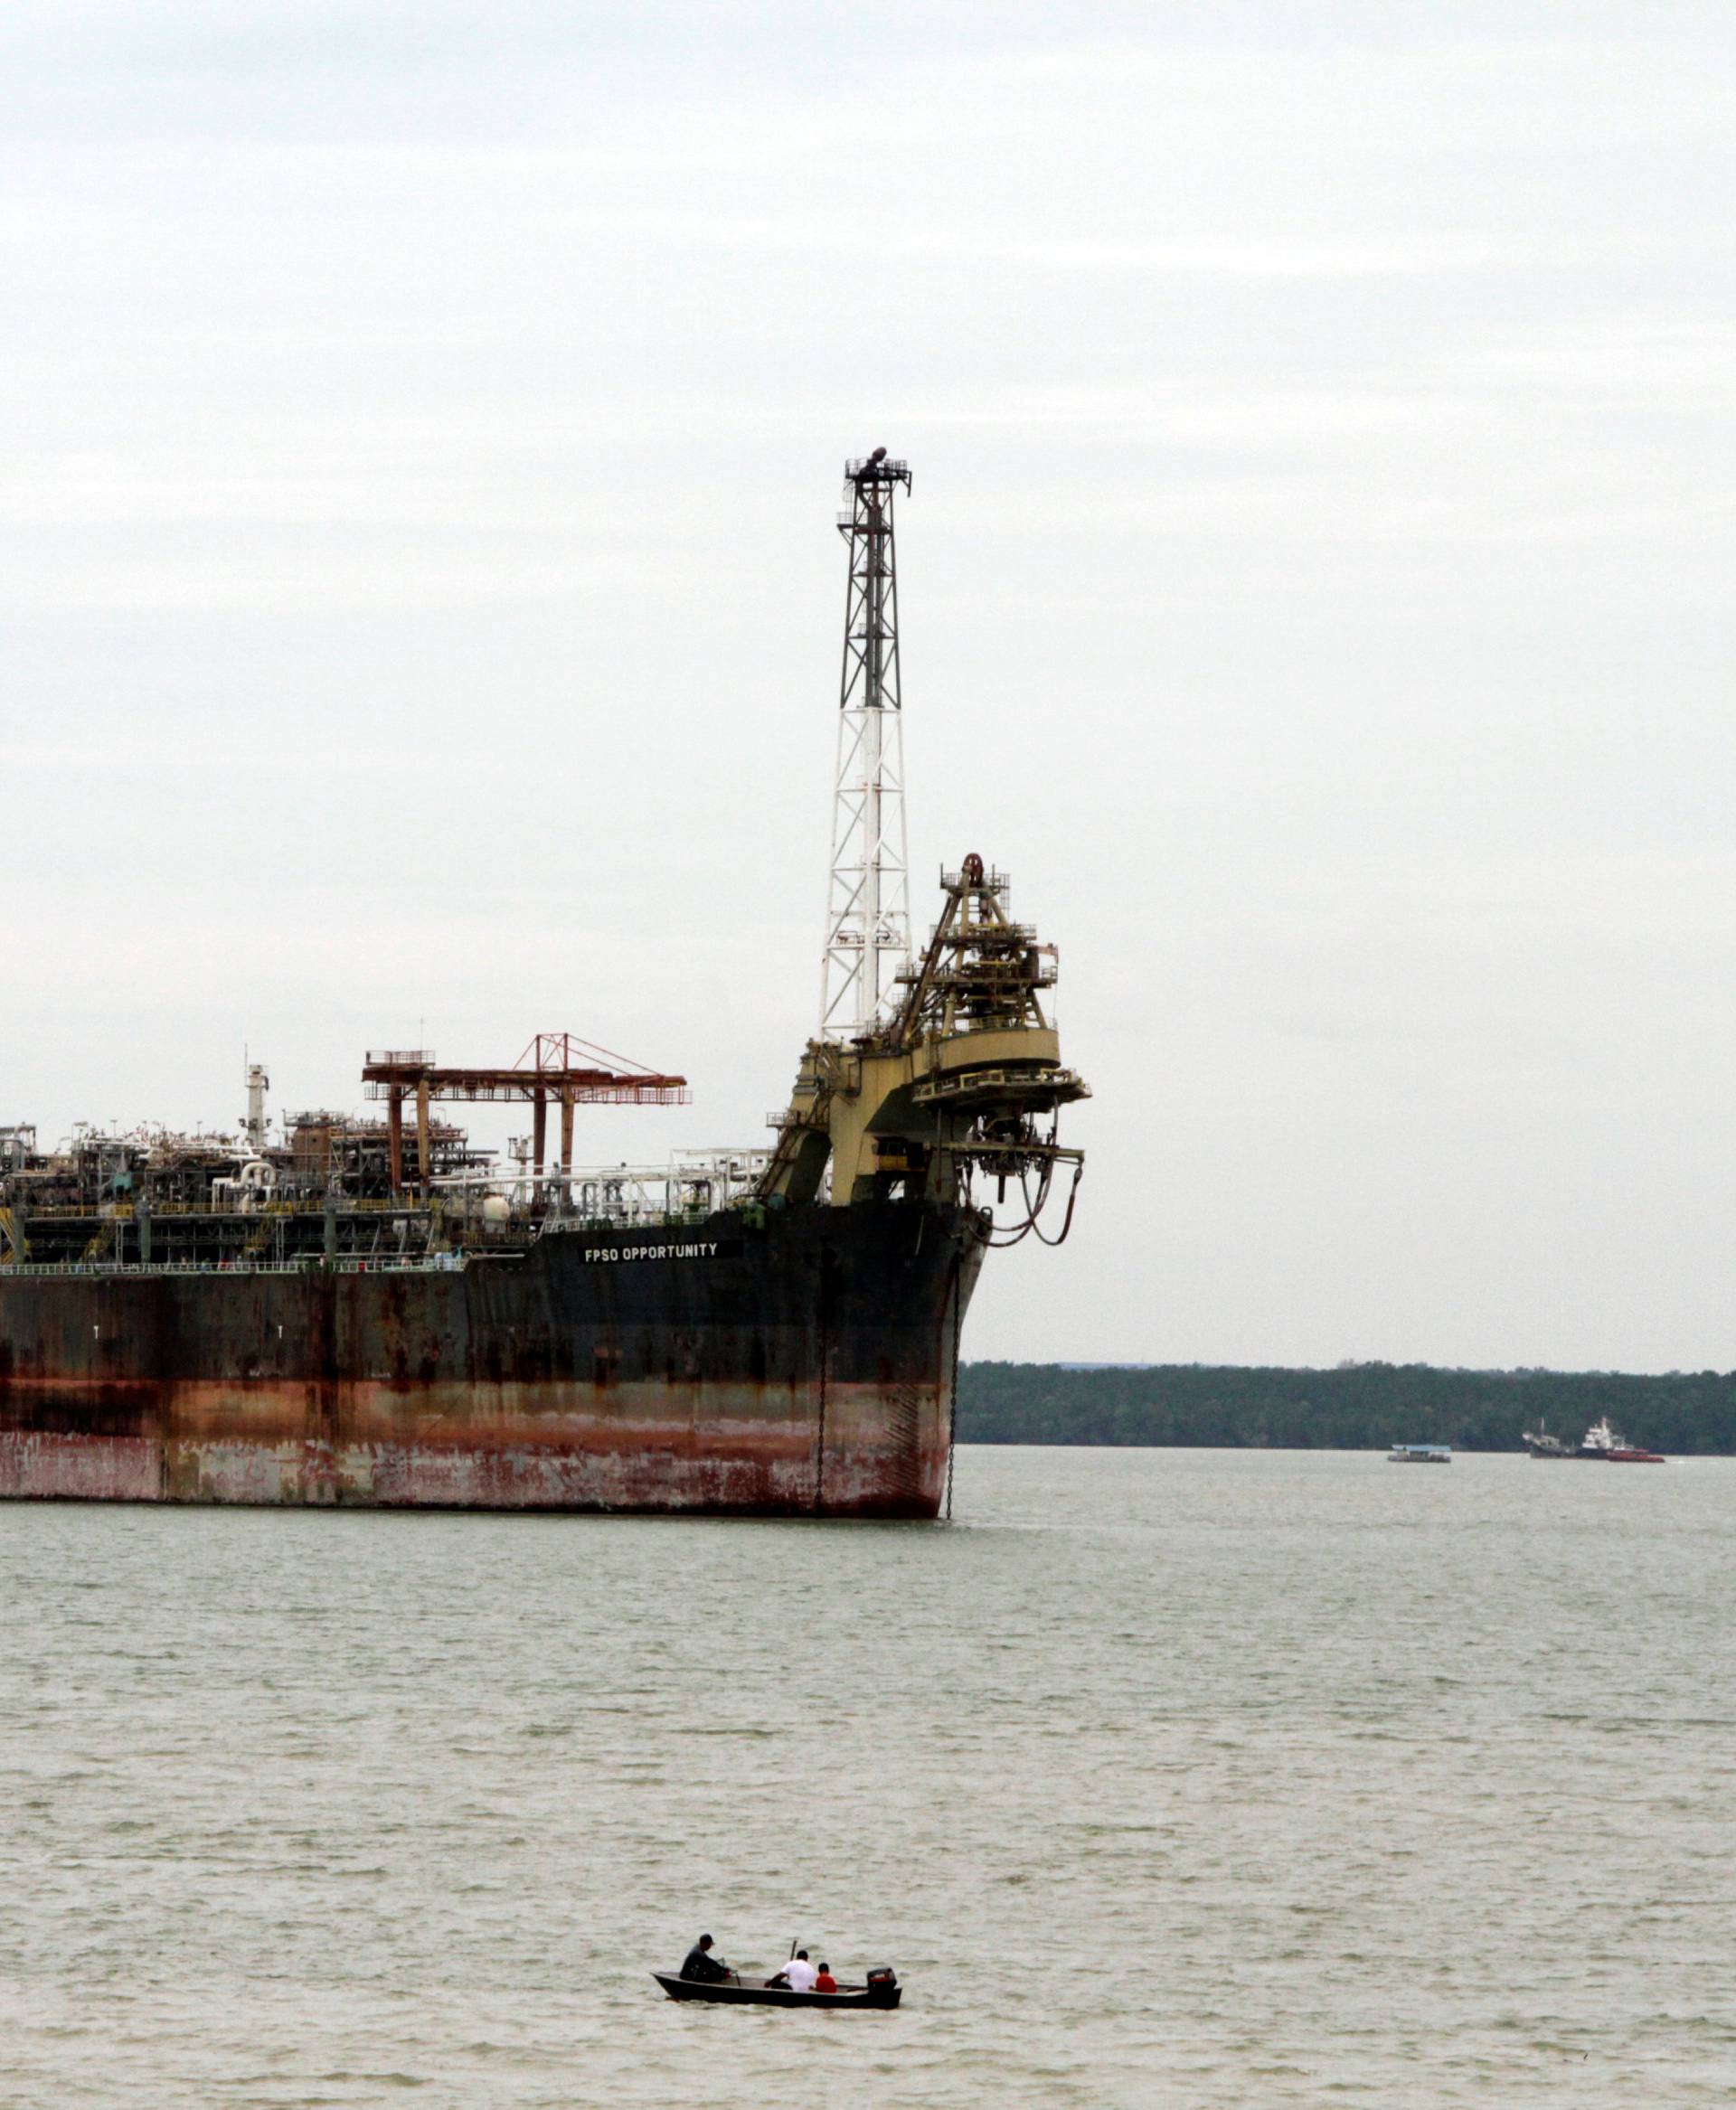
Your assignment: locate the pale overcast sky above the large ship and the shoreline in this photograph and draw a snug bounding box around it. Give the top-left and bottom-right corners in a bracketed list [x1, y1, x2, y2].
[0, 0, 1736, 1370]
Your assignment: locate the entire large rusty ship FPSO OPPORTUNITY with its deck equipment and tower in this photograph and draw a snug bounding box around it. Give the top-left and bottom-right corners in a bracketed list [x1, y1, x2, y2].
[0, 451, 1086, 1517]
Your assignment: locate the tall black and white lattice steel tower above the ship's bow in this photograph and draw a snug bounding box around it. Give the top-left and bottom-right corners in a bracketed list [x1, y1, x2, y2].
[821, 447, 911, 1041]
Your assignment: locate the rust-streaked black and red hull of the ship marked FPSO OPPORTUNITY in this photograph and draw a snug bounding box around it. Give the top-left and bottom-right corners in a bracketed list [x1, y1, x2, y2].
[0, 1201, 983, 1517]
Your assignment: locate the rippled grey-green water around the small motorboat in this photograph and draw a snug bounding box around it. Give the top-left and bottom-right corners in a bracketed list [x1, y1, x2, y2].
[0, 1449, 1736, 2110]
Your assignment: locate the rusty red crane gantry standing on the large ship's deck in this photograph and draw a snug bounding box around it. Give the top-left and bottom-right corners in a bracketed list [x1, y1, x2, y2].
[361, 1034, 692, 1194]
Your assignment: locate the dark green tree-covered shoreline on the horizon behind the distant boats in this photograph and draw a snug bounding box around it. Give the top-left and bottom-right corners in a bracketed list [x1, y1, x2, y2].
[958, 1363, 1736, 1454]
